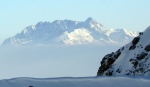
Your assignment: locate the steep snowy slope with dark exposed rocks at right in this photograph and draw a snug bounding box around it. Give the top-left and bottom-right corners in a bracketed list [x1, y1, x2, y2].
[97, 27, 150, 76]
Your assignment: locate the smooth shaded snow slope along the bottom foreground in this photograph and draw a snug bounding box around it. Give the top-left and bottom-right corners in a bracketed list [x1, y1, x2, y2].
[0, 76, 150, 87]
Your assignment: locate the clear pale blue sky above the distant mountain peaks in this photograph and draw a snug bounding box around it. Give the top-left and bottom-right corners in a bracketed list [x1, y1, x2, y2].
[0, 0, 150, 43]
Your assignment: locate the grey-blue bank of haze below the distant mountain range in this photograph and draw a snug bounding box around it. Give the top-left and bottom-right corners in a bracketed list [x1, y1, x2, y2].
[0, 45, 120, 80]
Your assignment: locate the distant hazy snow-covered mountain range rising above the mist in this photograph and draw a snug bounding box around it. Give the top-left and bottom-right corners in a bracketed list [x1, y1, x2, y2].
[3, 18, 137, 45]
